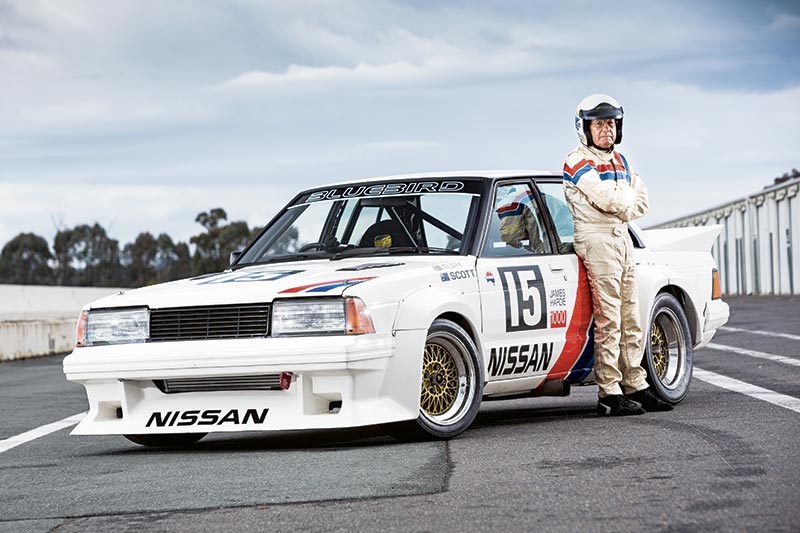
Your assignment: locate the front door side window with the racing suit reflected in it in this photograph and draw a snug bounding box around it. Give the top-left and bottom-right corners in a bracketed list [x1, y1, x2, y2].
[483, 182, 553, 257]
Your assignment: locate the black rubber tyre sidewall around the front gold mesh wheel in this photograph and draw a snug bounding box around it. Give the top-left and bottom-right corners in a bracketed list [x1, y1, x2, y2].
[416, 319, 483, 439]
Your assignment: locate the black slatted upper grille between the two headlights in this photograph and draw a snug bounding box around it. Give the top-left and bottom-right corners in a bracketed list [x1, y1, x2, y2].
[150, 303, 269, 342]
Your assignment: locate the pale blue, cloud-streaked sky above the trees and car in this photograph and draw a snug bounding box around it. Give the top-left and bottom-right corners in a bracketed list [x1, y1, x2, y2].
[0, 0, 800, 250]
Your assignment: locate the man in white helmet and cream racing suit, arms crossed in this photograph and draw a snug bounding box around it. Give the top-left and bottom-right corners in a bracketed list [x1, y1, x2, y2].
[564, 94, 672, 416]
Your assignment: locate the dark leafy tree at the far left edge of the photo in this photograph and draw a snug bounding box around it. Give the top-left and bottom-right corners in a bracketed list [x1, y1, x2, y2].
[0, 233, 55, 285]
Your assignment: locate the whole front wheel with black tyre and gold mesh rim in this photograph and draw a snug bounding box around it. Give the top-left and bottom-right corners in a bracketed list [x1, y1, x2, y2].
[388, 319, 483, 441]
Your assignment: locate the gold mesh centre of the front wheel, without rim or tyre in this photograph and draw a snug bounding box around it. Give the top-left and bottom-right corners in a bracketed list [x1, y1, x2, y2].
[420, 343, 459, 416]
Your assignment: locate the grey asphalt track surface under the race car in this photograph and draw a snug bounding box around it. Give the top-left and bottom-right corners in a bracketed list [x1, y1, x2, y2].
[0, 297, 800, 533]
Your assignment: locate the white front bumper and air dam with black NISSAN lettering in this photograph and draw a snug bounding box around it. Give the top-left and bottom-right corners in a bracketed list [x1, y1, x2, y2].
[64, 330, 426, 435]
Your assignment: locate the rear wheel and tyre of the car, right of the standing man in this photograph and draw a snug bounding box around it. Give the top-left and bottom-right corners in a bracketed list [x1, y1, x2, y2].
[642, 292, 694, 405]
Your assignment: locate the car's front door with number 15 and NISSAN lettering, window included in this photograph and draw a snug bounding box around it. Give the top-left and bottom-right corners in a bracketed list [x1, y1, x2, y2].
[477, 180, 578, 394]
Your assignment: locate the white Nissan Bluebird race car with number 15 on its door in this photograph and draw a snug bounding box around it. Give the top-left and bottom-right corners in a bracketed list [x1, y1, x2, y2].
[64, 171, 728, 446]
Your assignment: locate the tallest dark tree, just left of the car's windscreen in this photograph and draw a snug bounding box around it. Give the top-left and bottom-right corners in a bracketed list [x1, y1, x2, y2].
[189, 207, 250, 274]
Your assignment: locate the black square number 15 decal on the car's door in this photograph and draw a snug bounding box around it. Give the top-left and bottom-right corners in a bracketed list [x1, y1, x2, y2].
[497, 265, 547, 331]
